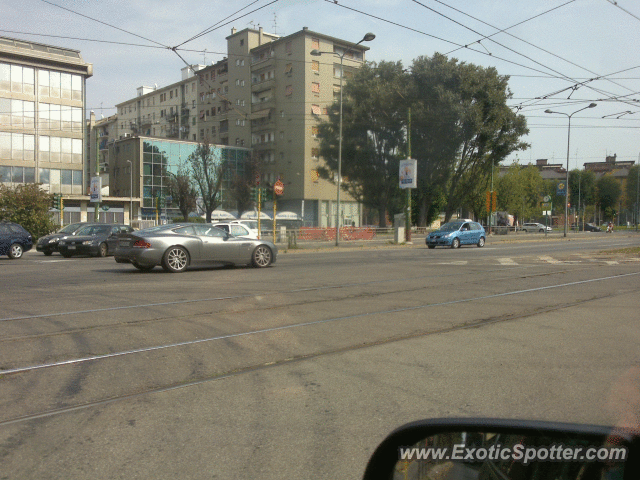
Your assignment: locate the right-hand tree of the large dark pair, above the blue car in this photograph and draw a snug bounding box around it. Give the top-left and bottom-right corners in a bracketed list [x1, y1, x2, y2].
[411, 54, 528, 225]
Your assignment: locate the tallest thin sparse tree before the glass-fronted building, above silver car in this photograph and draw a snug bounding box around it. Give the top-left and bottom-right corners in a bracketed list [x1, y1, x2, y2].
[188, 139, 226, 223]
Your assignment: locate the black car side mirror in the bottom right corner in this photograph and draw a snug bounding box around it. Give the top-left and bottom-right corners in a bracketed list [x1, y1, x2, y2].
[363, 418, 640, 480]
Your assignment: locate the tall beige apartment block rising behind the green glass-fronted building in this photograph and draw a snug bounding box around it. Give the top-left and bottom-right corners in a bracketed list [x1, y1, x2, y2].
[111, 27, 368, 227]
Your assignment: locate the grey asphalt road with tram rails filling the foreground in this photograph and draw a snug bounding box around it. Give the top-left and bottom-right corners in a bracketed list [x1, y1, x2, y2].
[0, 234, 640, 480]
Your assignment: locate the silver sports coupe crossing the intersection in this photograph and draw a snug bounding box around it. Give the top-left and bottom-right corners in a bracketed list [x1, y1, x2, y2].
[114, 223, 278, 273]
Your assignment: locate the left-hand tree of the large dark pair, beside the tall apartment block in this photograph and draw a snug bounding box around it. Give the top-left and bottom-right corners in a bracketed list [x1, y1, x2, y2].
[318, 62, 407, 227]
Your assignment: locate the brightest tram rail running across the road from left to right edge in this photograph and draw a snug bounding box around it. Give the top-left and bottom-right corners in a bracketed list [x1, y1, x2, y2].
[0, 272, 640, 375]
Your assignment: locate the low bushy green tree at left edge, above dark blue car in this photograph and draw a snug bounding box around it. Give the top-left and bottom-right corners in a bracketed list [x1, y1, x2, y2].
[0, 183, 56, 240]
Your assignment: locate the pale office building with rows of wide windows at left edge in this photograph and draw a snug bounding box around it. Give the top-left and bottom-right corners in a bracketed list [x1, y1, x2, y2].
[0, 37, 93, 198]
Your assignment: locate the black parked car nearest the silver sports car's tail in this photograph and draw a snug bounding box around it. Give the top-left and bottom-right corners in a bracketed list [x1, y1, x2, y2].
[58, 223, 133, 258]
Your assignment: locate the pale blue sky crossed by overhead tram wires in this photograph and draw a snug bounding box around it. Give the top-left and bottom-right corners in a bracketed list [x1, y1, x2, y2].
[5, 0, 640, 169]
